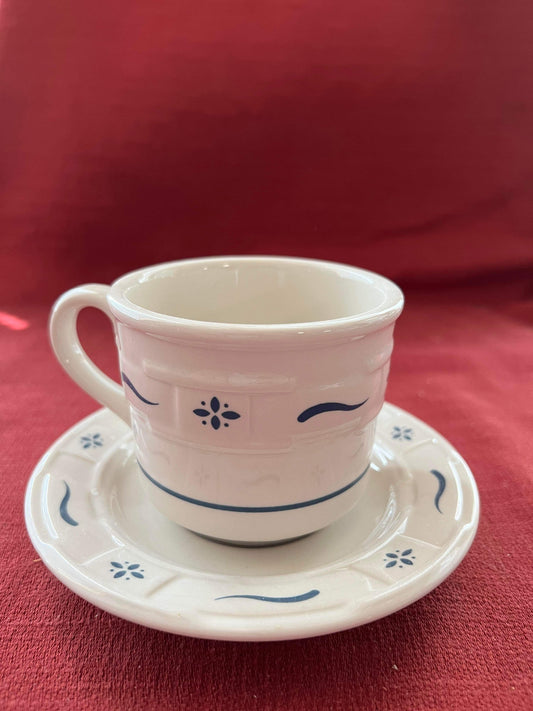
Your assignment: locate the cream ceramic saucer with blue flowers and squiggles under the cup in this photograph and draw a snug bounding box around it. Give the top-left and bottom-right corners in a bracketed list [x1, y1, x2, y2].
[25, 403, 479, 641]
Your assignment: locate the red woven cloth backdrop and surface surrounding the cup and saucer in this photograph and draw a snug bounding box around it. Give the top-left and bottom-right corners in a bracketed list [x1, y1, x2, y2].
[0, 0, 533, 711]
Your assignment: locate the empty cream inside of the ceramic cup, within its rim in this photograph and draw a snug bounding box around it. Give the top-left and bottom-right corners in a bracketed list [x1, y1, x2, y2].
[119, 257, 401, 325]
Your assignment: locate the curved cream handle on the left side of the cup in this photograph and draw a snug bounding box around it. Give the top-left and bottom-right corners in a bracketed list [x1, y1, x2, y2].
[49, 284, 130, 425]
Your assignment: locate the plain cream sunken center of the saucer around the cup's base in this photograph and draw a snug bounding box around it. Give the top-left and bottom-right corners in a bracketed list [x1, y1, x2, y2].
[98, 444, 414, 576]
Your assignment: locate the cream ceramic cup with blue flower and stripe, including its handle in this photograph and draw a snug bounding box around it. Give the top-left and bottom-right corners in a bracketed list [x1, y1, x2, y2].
[50, 257, 403, 544]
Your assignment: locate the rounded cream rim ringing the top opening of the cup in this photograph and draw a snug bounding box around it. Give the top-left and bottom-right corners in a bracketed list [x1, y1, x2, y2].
[107, 255, 404, 343]
